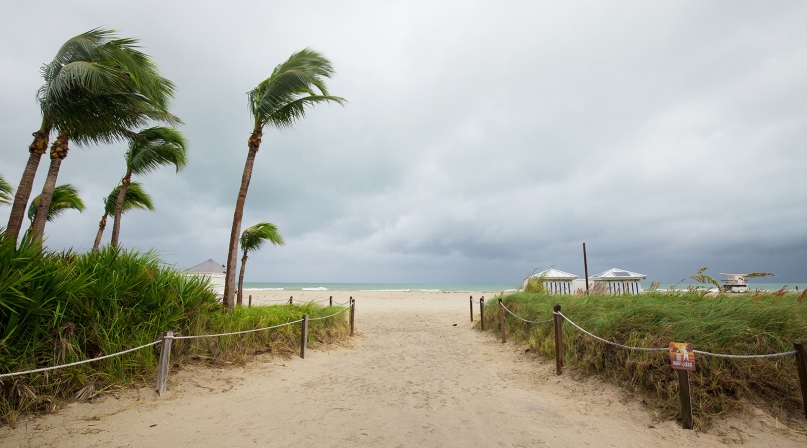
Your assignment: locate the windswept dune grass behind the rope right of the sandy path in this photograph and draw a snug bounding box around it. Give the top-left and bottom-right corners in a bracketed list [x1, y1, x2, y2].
[485, 291, 807, 427]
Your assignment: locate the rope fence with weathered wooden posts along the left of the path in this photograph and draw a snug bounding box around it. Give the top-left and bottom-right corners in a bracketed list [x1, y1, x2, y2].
[0, 297, 356, 396]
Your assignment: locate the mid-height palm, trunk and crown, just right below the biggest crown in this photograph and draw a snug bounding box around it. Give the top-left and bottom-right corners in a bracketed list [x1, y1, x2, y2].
[110, 126, 188, 246]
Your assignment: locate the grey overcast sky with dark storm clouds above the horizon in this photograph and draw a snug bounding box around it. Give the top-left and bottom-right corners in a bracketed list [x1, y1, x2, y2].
[0, 0, 807, 284]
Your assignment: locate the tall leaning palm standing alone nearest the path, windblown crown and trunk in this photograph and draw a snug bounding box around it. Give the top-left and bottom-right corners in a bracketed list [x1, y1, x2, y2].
[224, 48, 345, 309]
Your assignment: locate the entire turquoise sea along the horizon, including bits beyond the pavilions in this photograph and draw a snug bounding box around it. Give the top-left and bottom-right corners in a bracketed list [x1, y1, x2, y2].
[244, 282, 807, 292]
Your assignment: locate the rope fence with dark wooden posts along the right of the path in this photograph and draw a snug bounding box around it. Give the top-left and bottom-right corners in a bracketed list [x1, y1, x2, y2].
[471, 297, 807, 429]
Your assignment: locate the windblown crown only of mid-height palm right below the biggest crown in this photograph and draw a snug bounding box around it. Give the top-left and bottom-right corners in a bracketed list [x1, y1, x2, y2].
[125, 126, 188, 174]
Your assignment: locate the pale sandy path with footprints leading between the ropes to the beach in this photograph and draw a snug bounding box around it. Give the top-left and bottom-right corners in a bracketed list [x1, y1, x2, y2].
[0, 293, 807, 447]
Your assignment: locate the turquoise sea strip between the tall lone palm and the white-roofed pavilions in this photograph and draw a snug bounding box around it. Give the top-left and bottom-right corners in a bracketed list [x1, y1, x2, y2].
[244, 282, 521, 292]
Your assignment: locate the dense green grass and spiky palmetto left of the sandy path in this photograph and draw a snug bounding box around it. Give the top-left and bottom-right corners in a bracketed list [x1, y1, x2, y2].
[0, 237, 349, 425]
